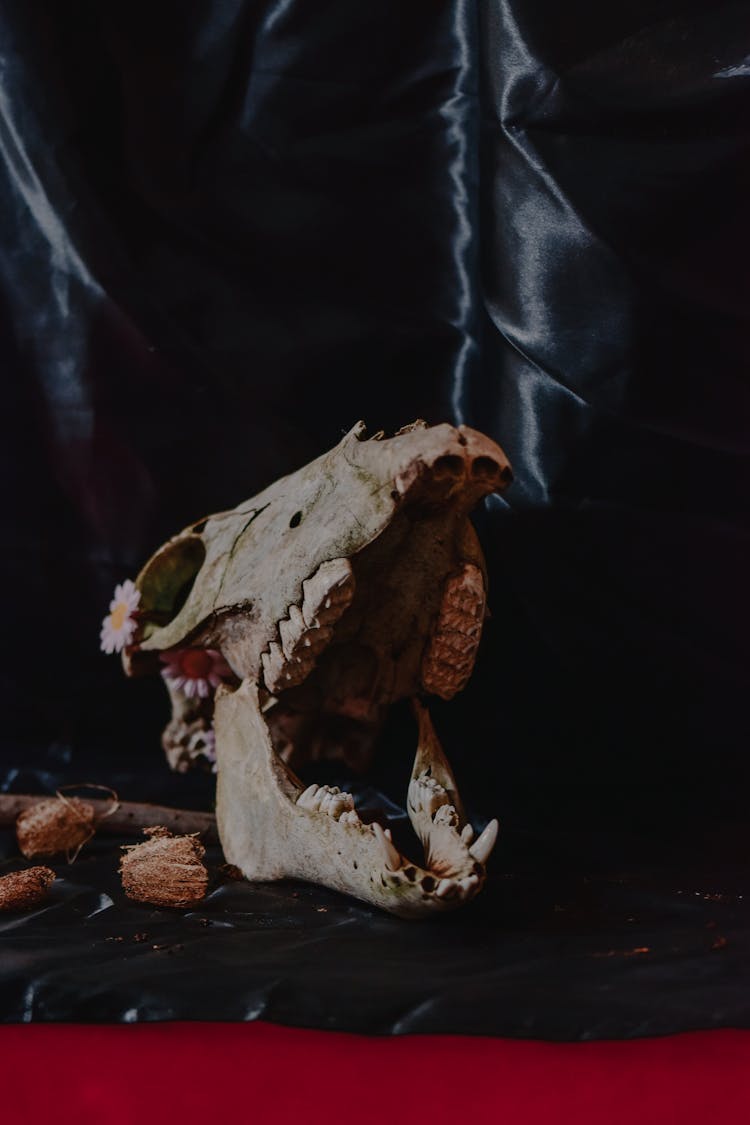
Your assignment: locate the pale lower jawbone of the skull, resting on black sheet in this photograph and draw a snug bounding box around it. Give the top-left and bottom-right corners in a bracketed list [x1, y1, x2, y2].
[214, 681, 496, 917]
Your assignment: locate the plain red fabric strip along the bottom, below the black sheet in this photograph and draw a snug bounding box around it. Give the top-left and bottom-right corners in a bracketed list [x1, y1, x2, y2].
[0, 1023, 750, 1125]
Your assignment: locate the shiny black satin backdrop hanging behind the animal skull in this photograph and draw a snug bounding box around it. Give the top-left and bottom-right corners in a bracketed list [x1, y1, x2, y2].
[0, 0, 750, 1034]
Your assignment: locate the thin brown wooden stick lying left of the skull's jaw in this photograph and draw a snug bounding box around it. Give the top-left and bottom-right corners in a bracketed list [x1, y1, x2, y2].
[0, 793, 219, 844]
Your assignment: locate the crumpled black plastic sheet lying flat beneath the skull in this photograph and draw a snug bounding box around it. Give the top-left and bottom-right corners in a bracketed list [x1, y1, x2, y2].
[0, 774, 750, 1040]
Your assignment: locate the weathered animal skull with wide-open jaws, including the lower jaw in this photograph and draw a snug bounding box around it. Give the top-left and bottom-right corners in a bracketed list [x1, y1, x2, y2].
[124, 423, 512, 917]
